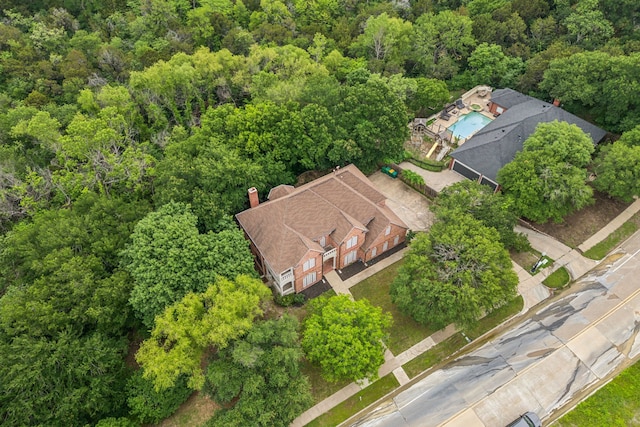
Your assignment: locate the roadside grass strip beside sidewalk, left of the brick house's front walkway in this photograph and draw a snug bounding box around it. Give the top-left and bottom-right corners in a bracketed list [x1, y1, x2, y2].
[307, 373, 400, 427]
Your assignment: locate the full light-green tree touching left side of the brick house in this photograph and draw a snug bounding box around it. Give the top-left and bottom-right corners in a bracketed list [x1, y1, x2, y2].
[123, 202, 255, 328]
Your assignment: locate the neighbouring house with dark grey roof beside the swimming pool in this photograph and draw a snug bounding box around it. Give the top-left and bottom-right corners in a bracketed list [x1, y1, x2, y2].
[450, 89, 606, 189]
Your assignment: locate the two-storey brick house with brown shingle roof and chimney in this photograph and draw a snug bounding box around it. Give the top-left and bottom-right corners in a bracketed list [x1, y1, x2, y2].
[236, 165, 408, 295]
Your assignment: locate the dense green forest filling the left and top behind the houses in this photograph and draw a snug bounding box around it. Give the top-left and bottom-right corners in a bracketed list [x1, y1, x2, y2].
[0, 0, 640, 426]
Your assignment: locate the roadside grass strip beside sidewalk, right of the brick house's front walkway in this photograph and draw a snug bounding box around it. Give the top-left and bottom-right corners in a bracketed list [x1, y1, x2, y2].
[403, 296, 524, 378]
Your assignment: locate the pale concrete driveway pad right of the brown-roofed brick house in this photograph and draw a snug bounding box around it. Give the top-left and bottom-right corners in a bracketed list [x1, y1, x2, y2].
[369, 172, 433, 231]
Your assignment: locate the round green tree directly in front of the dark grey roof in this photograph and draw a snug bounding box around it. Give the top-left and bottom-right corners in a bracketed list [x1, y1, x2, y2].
[498, 121, 594, 222]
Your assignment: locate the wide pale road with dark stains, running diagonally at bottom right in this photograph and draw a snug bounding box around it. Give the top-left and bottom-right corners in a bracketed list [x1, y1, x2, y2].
[354, 233, 640, 427]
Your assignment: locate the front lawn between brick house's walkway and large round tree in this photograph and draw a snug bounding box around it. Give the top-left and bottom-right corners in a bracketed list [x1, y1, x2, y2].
[350, 261, 436, 355]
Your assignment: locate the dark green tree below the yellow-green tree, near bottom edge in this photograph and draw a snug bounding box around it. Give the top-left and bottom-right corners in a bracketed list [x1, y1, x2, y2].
[205, 315, 313, 427]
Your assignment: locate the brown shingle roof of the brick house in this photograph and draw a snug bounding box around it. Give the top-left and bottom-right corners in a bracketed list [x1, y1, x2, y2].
[236, 165, 406, 273]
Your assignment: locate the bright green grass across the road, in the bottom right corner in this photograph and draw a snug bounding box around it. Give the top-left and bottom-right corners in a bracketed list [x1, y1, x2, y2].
[555, 362, 640, 427]
